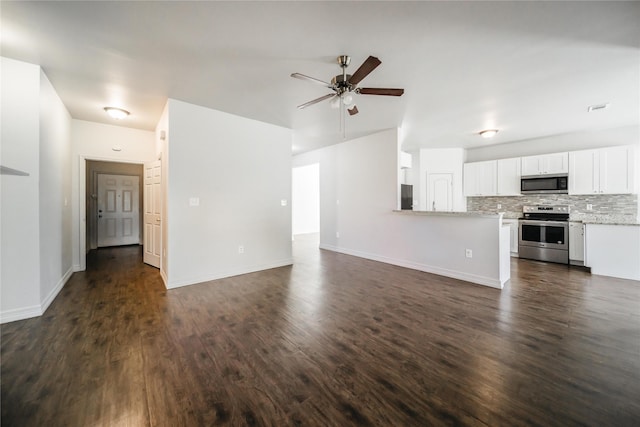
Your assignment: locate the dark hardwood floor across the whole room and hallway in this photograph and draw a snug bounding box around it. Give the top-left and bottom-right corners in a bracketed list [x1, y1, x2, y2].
[1, 239, 640, 427]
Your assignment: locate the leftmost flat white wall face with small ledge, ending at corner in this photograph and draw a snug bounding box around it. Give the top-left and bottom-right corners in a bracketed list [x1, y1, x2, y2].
[0, 58, 41, 322]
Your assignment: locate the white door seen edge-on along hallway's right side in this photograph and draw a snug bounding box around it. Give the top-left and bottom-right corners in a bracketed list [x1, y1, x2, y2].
[143, 160, 162, 268]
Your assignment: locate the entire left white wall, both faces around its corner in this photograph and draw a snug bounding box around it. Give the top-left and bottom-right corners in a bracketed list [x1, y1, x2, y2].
[0, 58, 72, 323]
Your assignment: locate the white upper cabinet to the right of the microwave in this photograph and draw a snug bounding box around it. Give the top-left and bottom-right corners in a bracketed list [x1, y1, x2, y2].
[569, 146, 637, 194]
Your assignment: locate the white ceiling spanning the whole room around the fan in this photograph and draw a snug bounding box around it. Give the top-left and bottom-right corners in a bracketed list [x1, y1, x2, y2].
[1, 1, 640, 152]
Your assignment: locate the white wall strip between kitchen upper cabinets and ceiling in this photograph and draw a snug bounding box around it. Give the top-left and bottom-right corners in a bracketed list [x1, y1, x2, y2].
[466, 126, 640, 162]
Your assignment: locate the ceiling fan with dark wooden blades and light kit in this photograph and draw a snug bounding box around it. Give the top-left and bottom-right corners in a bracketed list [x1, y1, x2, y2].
[291, 55, 404, 116]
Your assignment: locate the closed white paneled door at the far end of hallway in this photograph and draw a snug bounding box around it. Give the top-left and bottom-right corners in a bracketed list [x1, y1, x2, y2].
[98, 174, 140, 247]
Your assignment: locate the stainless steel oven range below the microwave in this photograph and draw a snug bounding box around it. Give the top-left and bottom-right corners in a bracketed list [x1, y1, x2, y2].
[518, 205, 569, 264]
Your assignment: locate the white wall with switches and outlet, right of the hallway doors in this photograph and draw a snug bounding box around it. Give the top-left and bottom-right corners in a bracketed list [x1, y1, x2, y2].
[166, 99, 292, 288]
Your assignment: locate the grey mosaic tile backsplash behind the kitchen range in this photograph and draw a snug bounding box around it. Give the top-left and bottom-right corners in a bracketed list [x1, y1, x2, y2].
[467, 194, 638, 220]
